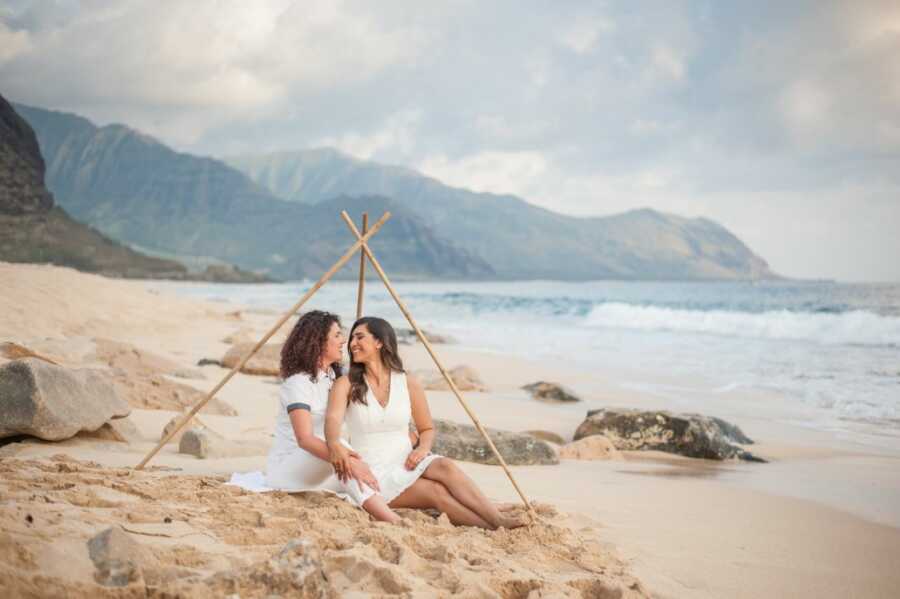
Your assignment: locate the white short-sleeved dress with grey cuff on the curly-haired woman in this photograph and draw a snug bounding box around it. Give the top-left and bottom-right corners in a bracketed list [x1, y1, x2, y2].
[265, 369, 377, 506]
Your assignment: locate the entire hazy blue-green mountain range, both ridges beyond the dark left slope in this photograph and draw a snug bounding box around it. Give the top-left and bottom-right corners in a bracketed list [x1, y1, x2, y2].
[16, 105, 776, 280]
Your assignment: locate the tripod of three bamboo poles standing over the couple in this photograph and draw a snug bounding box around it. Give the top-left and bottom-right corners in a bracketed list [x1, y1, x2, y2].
[135, 211, 537, 521]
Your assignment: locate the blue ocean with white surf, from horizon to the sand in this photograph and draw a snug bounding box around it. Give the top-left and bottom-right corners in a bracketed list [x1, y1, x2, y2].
[150, 280, 900, 445]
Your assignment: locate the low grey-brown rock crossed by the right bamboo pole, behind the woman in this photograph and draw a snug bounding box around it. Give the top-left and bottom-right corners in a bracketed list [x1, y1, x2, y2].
[432, 420, 559, 466]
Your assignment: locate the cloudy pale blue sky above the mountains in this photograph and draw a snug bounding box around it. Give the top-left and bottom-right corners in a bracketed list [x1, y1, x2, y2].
[0, 0, 900, 281]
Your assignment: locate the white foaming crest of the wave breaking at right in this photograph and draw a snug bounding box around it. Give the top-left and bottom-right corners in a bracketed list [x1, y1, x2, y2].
[585, 302, 900, 346]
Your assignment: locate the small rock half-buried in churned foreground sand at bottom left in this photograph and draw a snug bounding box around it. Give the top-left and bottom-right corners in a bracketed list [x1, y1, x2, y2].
[87, 526, 156, 587]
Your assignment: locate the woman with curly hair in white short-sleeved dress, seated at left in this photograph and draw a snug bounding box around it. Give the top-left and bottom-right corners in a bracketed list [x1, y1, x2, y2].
[266, 310, 399, 522]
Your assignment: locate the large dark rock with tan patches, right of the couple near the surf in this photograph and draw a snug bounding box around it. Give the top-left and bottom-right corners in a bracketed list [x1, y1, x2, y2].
[575, 408, 765, 462]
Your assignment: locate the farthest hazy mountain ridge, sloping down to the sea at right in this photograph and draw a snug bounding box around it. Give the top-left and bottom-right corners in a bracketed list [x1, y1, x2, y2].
[224, 148, 777, 280]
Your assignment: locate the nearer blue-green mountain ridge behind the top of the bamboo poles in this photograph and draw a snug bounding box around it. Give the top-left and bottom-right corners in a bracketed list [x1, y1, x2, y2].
[17, 106, 493, 279]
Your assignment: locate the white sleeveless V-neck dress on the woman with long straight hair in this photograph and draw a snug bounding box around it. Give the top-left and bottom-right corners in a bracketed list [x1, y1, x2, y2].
[345, 372, 440, 503]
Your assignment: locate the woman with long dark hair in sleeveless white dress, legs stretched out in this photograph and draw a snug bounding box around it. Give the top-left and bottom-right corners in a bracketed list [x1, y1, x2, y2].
[325, 317, 524, 529]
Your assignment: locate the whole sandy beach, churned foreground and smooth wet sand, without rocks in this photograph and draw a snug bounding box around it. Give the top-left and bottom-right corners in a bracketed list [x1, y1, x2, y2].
[0, 263, 900, 598]
